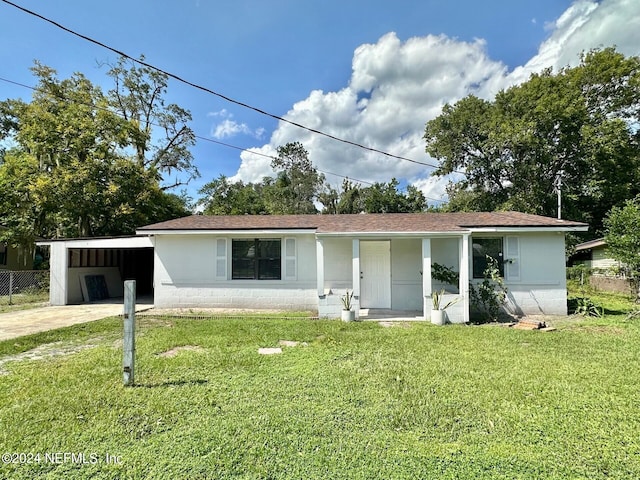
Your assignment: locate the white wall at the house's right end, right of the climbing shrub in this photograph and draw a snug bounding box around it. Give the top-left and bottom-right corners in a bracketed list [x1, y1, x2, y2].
[505, 233, 567, 315]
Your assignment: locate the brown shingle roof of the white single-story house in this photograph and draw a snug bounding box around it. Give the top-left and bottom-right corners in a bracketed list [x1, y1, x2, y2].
[138, 212, 588, 233]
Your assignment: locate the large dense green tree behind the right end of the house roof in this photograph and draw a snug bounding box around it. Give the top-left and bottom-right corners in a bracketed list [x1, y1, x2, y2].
[424, 49, 640, 234]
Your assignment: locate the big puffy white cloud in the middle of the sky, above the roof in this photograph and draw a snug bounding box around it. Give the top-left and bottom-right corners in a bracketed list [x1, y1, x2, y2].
[233, 33, 506, 197]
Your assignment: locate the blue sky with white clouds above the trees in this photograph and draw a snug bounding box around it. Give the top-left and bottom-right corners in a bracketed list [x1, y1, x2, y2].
[0, 0, 640, 203]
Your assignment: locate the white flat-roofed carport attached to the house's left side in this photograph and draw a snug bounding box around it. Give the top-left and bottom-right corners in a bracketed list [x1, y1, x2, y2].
[37, 235, 153, 305]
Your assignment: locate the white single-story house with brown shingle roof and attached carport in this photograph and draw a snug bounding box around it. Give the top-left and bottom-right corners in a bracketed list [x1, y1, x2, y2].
[42, 212, 588, 322]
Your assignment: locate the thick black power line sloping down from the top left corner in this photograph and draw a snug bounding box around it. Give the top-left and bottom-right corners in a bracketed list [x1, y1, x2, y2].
[0, 0, 466, 175]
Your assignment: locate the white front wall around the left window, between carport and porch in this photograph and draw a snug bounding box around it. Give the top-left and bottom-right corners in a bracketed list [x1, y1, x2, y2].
[154, 234, 318, 311]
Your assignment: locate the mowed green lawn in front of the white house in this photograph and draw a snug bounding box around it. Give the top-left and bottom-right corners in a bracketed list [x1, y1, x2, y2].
[0, 308, 640, 479]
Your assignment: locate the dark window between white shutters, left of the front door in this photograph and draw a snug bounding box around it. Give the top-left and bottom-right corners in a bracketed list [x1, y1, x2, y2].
[231, 238, 282, 280]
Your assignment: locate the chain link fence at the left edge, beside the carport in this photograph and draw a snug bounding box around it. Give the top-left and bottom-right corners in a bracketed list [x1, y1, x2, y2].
[0, 270, 49, 305]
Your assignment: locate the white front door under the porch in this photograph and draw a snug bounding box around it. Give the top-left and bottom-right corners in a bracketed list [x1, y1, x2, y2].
[360, 241, 391, 308]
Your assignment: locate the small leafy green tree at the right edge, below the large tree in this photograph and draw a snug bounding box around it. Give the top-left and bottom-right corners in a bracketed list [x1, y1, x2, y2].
[604, 196, 640, 303]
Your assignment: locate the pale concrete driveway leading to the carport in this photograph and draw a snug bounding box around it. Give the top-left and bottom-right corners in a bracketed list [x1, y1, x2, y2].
[0, 299, 153, 340]
